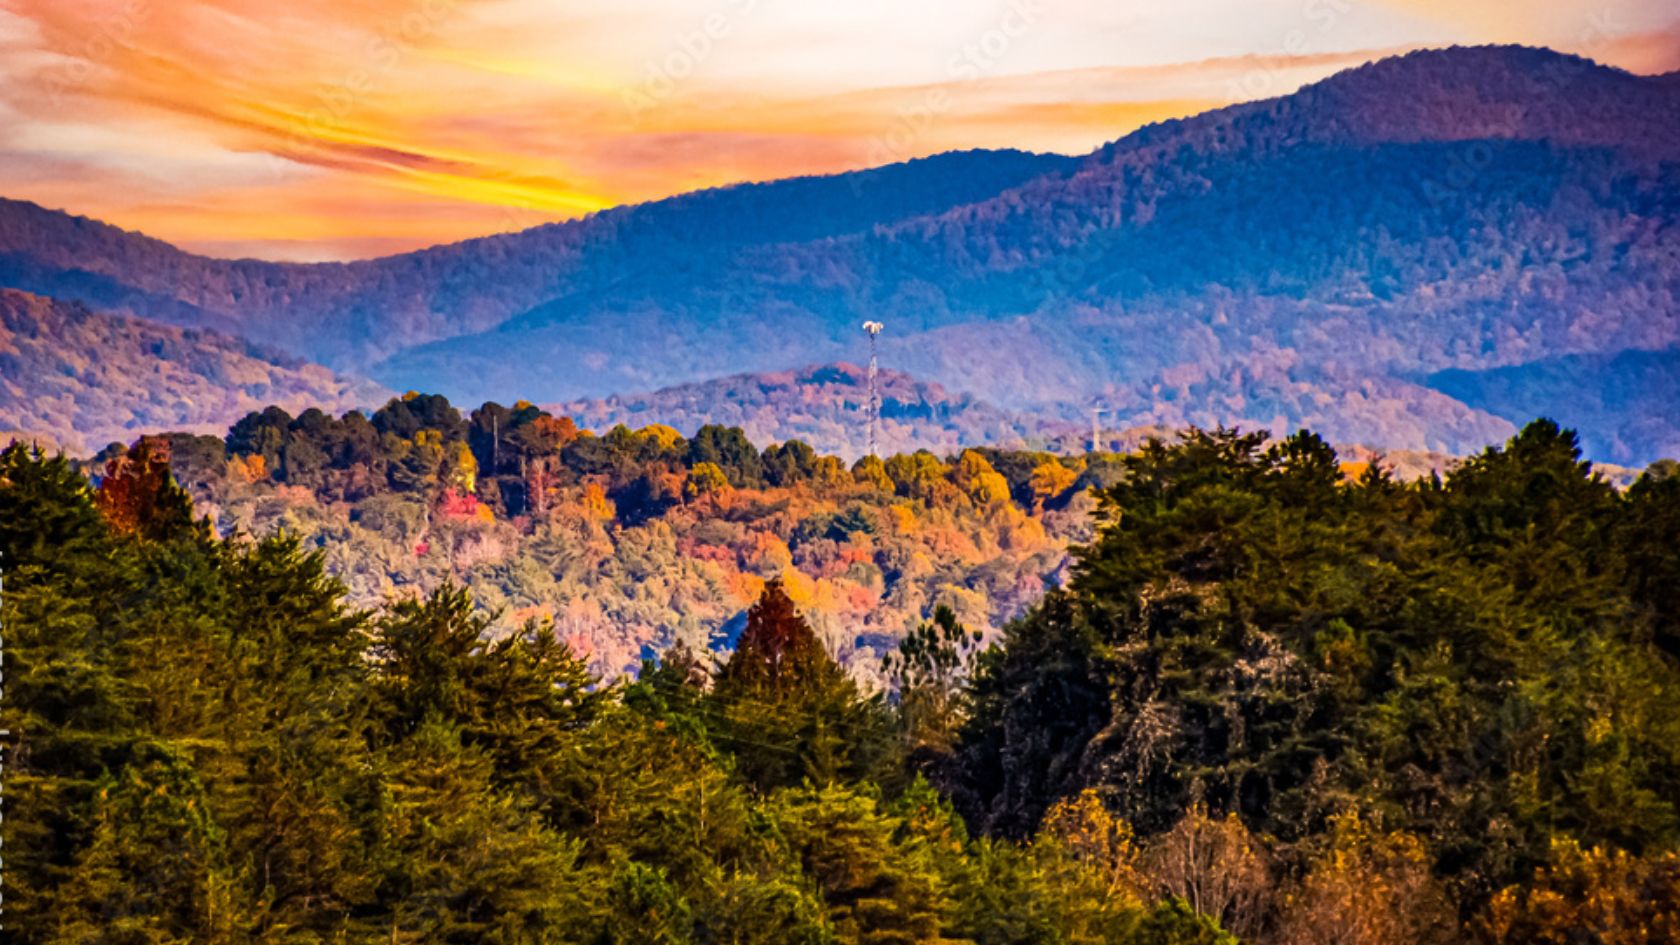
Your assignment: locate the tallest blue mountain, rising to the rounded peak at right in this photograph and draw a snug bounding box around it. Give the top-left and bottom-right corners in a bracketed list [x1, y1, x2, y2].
[376, 47, 1680, 452]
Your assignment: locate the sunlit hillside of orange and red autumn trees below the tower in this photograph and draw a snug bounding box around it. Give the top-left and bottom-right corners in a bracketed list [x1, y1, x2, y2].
[137, 395, 1095, 676]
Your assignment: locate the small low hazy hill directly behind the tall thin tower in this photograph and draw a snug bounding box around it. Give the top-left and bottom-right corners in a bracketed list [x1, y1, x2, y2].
[549, 363, 1041, 461]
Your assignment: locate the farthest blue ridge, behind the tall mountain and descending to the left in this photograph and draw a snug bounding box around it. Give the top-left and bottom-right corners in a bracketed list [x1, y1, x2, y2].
[0, 151, 1074, 367]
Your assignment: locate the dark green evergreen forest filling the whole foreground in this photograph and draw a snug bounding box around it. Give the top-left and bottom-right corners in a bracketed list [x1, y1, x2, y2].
[0, 417, 1680, 945]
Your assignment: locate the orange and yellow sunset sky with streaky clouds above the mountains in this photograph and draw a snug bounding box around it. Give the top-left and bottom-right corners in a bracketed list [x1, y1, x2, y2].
[0, 0, 1680, 261]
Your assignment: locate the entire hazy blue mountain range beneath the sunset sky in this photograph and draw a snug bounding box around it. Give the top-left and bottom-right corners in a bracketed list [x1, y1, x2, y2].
[0, 47, 1680, 464]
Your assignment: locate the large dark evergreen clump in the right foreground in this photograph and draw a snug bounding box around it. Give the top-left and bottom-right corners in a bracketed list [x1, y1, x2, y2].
[958, 422, 1680, 893]
